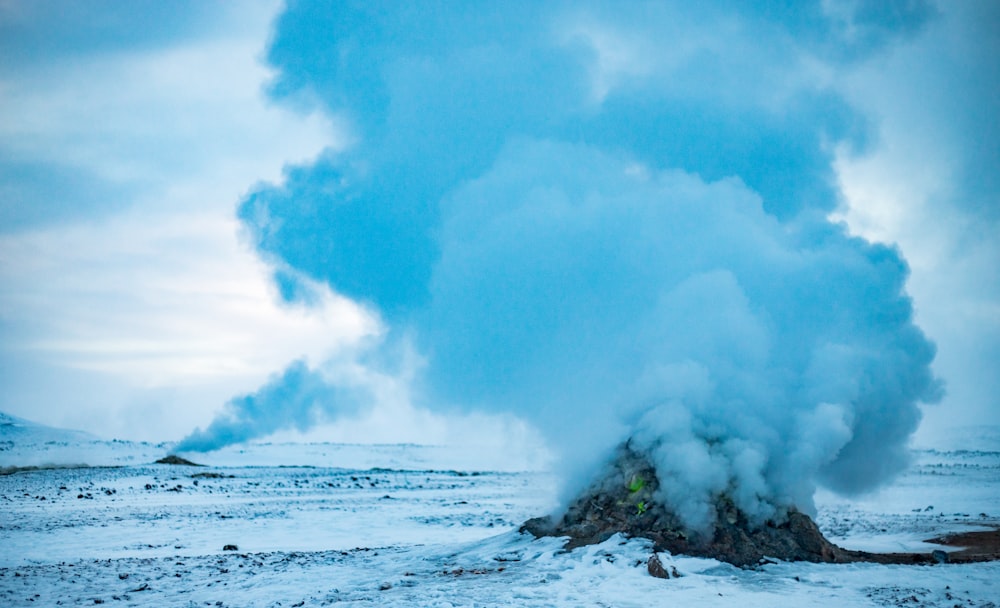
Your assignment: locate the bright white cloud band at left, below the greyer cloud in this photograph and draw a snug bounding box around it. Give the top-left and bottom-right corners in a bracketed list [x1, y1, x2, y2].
[0, 213, 377, 387]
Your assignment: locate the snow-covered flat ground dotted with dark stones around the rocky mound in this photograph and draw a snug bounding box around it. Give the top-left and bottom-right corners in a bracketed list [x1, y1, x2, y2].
[0, 416, 1000, 608]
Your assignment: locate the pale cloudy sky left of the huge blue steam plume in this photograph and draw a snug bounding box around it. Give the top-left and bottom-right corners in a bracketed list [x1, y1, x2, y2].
[0, 3, 378, 440]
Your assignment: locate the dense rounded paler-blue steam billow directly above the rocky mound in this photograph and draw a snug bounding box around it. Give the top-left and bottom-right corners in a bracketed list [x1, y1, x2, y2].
[419, 142, 938, 526]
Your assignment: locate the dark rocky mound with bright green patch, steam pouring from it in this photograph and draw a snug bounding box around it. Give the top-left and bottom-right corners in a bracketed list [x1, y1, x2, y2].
[521, 443, 941, 567]
